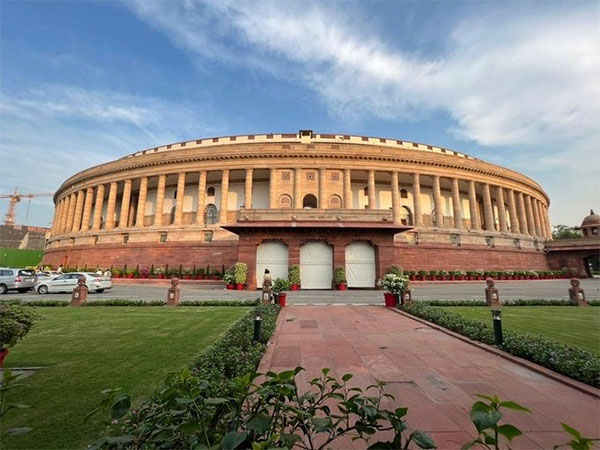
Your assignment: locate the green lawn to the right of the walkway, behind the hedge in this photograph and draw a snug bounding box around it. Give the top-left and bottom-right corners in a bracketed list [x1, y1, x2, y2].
[444, 306, 600, 356]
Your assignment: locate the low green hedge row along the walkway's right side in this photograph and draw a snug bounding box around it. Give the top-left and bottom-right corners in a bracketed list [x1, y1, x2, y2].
[402, 302, 600, 388]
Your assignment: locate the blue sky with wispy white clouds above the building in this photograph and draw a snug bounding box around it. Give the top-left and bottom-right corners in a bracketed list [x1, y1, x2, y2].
[0, 0, 600, 226]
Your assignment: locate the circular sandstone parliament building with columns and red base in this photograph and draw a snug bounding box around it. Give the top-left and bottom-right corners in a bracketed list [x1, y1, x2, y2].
[43, 130, 551, 289]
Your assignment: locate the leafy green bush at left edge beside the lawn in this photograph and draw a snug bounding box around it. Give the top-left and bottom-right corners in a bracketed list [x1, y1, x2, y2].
[0, 305, 40, 368]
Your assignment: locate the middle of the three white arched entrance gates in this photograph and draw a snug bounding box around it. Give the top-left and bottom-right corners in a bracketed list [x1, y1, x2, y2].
[300, 242, 333, 289]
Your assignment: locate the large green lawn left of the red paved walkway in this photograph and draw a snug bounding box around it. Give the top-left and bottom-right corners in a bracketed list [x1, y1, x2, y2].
[0, 306, 248, 450]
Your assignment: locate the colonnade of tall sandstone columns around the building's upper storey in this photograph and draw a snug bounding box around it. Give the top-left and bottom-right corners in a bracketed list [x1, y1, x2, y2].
[52, 168, 551, 238]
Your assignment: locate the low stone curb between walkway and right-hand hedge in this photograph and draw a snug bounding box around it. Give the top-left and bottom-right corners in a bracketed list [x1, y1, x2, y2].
[388, 308, 600, 399]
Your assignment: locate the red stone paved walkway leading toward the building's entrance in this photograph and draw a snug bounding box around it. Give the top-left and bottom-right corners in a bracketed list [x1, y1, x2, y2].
[259, 306, 600, 449]
